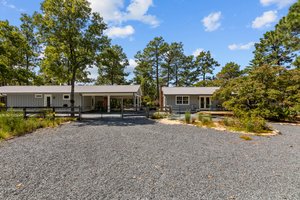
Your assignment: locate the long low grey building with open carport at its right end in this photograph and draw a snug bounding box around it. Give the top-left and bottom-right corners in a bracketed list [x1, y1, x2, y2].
[0, 85, 142, 112]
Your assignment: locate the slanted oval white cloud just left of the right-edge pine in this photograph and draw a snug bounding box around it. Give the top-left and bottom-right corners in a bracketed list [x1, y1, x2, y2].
[252, 10, 277, 29]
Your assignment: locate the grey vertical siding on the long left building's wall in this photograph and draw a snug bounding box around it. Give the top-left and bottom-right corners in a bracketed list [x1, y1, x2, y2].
[7, 93, 81, 107]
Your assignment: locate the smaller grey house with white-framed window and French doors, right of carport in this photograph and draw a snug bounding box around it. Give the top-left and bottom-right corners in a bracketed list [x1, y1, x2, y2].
[162, 87, 219, 112]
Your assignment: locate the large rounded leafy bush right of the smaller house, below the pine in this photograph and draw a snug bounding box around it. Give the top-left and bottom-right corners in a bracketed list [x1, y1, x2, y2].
[214, 65, 300, 120]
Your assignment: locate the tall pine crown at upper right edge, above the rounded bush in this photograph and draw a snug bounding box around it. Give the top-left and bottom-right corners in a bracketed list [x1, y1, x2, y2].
[252, 1, 300, 68]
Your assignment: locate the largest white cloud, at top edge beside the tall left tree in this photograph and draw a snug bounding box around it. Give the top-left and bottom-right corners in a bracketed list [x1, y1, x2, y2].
[89, 0, 159, 27]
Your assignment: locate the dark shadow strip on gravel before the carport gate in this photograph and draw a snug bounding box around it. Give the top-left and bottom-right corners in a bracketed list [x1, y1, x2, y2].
[76, 117, 156, 127]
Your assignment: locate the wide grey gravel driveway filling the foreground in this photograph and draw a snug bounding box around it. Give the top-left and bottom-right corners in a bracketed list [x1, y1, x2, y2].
[0, 118, 300, 199]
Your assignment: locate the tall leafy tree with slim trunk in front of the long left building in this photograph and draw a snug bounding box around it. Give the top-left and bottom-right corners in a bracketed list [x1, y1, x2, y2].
[35, 0, 110, 111]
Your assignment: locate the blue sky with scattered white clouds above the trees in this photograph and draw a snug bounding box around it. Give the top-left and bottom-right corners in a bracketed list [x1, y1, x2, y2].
[0, 0, 296, 77]
